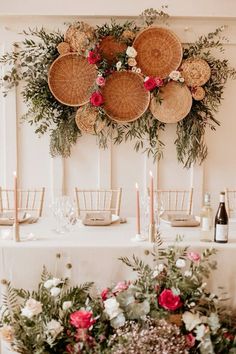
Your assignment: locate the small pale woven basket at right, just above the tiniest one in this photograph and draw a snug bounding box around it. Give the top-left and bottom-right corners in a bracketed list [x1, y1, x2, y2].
[180, 58, 211, 87]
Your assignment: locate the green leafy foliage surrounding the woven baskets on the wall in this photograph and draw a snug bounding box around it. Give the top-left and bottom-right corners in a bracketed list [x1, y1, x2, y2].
[0, 9, 236, 168]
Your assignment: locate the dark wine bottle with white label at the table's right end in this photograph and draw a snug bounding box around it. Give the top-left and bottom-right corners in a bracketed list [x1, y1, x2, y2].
[214, 192, 228, 243]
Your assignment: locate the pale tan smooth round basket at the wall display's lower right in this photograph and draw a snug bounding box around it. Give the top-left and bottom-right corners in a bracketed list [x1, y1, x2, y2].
[150, 81, 192, 123]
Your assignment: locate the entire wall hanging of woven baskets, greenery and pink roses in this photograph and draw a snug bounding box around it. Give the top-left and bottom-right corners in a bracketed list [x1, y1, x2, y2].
[0, 8, 236, 167]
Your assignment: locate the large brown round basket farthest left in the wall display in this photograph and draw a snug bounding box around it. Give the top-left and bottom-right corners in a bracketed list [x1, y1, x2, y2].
[48, 53, 97, 106]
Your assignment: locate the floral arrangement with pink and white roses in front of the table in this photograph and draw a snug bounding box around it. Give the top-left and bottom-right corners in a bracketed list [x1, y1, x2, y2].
[0, 243, 236, 354]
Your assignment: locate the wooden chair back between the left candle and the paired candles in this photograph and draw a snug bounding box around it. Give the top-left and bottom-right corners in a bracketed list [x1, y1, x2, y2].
[75, 187, 122, 216]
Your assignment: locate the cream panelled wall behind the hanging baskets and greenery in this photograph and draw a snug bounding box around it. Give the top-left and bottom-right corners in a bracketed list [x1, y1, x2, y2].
[0, 0, 236, 215]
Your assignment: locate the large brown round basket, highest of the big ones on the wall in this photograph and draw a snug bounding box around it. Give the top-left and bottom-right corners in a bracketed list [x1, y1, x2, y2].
[133, 27, 183, 79]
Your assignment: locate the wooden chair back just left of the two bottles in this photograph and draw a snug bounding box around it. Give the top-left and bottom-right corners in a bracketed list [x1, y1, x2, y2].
[154, 188, 193, 215]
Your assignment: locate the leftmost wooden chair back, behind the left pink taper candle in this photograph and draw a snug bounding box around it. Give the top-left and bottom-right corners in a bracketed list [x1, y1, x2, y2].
[0, 187, 45, 217]
